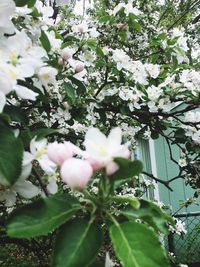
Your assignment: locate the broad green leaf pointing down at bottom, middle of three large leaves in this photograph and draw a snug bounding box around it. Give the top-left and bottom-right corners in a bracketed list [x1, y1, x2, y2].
[53, 219, 102, 267]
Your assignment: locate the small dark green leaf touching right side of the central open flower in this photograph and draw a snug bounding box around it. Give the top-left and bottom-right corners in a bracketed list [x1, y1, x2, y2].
[110, 158, 143, 181]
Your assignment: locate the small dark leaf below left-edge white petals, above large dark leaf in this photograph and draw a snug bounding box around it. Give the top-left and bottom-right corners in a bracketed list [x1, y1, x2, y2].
[4, 105, 28, 124]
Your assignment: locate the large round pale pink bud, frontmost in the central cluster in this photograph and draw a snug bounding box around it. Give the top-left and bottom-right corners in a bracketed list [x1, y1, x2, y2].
[60, 158, 93, 189]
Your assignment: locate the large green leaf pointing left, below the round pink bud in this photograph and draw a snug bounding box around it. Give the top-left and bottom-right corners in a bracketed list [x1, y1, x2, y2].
[7, 194, 81, 238]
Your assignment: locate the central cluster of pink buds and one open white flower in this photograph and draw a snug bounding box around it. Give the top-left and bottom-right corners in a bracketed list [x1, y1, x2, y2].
[47, 128, 130, 189]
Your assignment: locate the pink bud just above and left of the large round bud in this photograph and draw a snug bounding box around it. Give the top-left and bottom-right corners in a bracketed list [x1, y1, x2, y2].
[47, 142, 73, 165]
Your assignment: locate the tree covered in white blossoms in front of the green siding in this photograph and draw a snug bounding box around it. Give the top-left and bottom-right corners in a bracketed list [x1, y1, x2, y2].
[0, 0, 200, 267]
